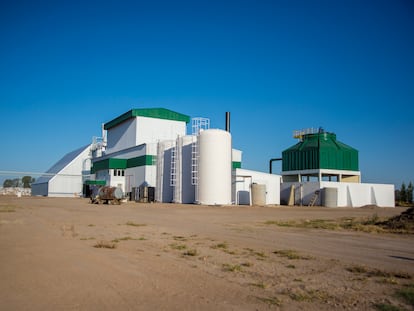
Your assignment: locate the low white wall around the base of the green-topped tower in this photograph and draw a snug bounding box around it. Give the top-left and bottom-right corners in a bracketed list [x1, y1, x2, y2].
[280, 181, 395, 207]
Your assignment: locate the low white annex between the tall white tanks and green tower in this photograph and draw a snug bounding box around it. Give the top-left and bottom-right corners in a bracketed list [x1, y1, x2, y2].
[232, 168, 282, 205]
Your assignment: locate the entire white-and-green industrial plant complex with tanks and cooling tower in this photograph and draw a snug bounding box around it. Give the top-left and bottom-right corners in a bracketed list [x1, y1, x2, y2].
[32, 108, 394, 207]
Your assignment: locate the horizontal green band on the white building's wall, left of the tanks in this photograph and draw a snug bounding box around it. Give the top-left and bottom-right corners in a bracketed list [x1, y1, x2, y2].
[91, 154, 157, 174]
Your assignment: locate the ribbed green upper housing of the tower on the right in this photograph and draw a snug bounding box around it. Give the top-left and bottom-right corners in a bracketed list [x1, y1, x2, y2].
[282, 132, 358, 171]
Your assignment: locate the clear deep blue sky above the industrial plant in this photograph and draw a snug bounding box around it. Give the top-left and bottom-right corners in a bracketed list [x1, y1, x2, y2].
[0, 0, 414, 187]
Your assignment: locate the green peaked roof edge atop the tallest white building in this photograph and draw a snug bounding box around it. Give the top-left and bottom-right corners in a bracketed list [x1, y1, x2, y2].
[104, 108, 190, 130]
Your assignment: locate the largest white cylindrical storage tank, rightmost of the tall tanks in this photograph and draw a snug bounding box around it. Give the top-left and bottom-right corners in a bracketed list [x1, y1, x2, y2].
[197, 129, 232, 205]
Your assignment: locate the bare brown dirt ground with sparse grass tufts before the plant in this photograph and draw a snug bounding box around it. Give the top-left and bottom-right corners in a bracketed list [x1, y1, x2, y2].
[0, 196, 414, 310]
